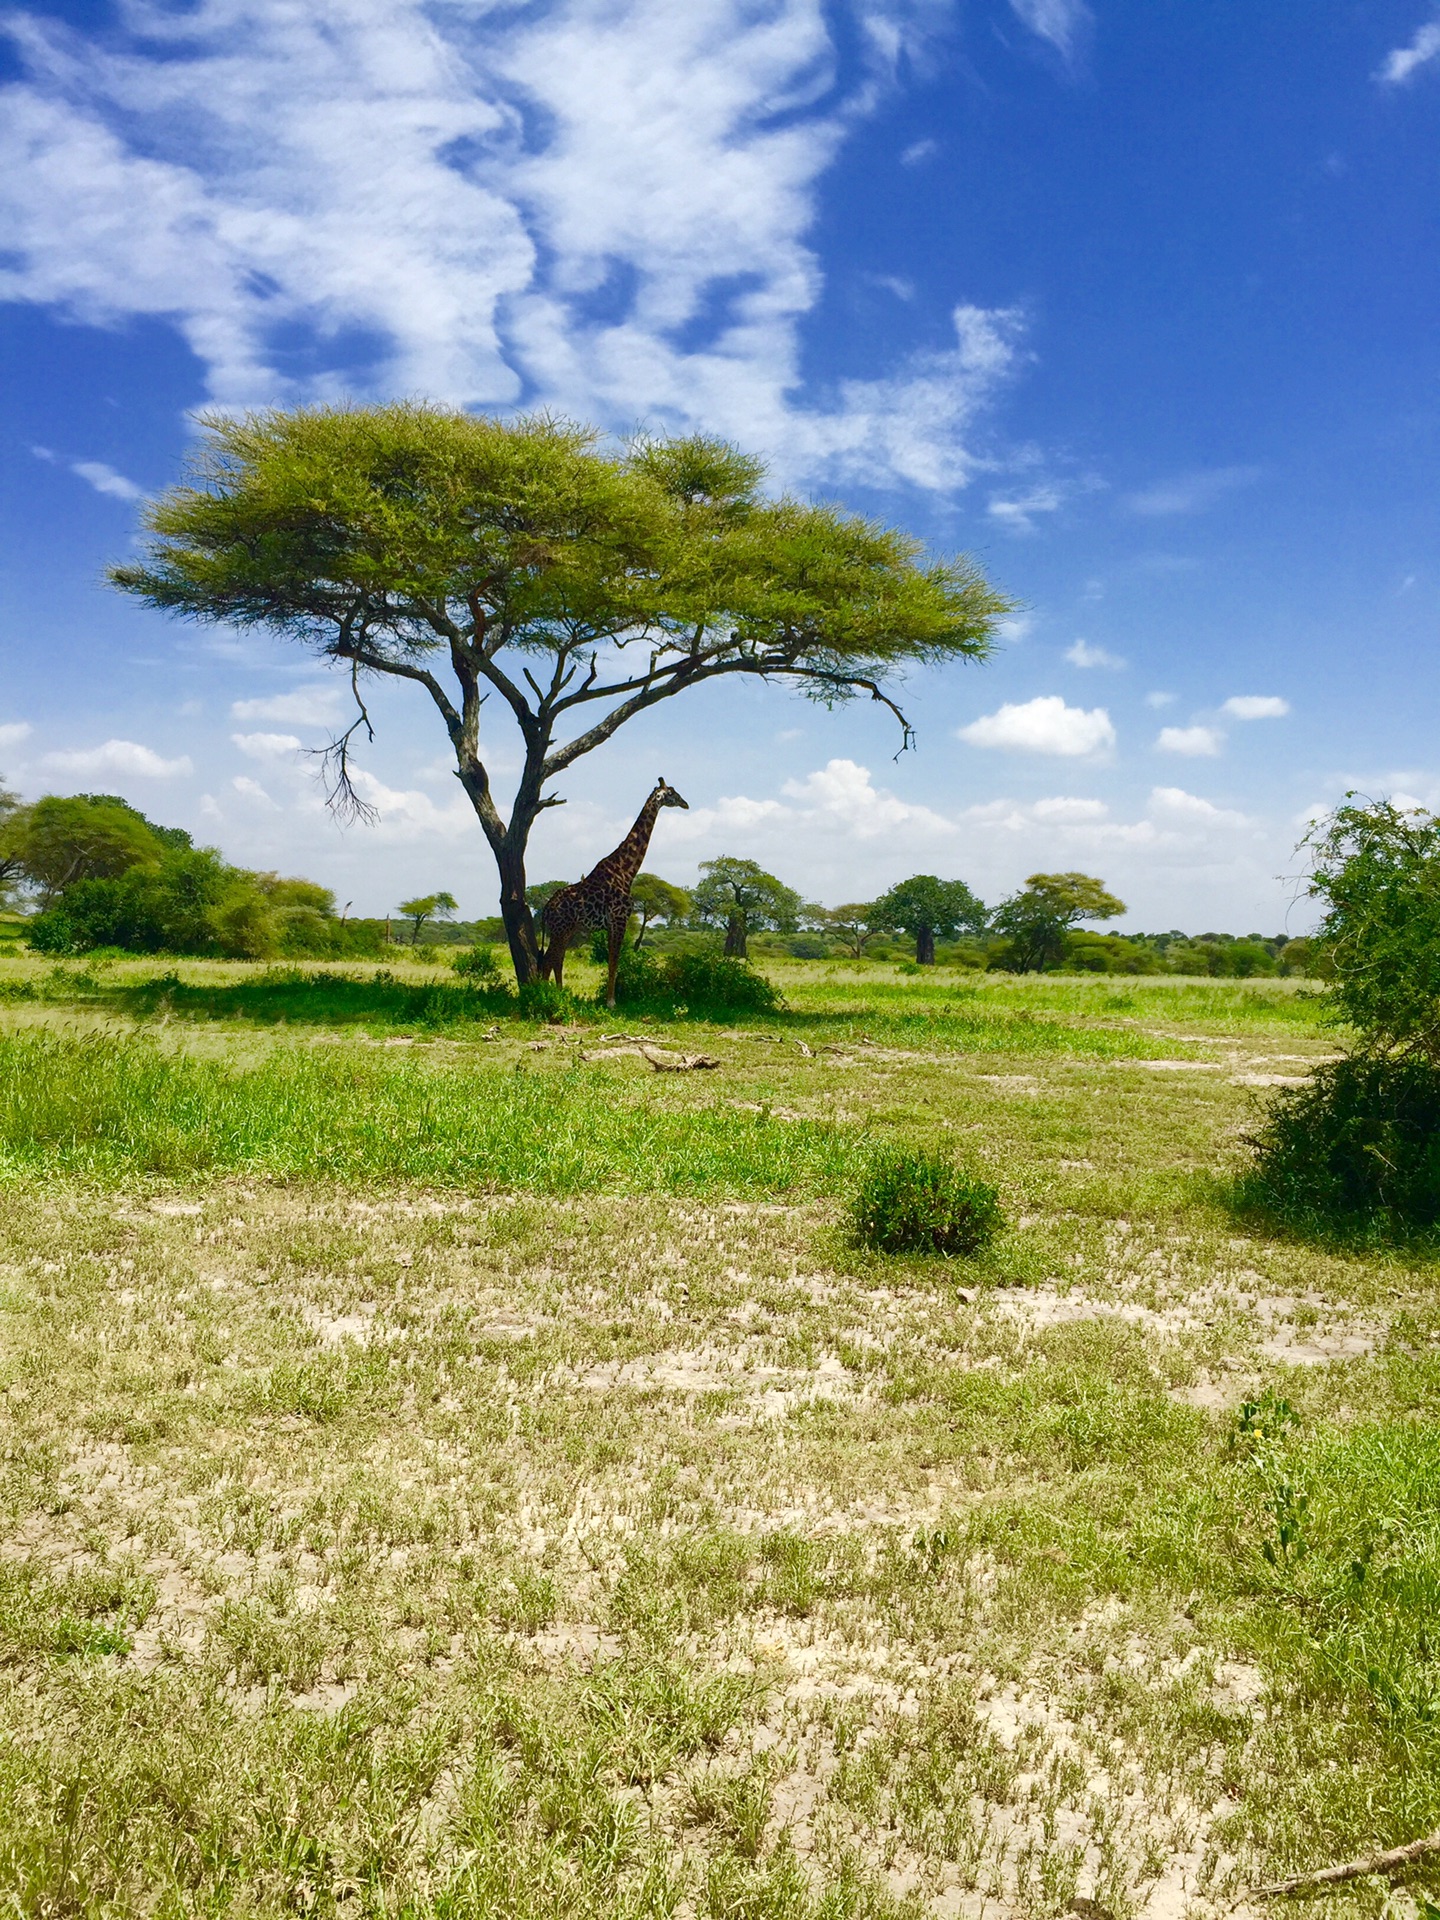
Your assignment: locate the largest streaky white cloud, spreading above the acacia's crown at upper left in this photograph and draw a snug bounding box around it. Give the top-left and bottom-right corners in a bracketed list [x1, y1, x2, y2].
[0, 0, 1029, 490]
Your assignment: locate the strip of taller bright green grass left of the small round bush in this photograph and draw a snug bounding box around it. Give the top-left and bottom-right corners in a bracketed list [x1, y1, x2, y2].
[0, 1035, 860, 1194]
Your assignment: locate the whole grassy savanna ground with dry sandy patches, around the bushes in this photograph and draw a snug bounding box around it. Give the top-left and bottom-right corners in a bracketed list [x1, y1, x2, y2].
[0, 958, 1440, 1920]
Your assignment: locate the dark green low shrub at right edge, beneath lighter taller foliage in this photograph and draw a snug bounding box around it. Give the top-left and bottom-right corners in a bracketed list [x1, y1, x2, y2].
[1240, 1054, 1440, 1229]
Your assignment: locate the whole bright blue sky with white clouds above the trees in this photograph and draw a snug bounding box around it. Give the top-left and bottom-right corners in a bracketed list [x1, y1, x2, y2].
[0, 0, 1440, 931]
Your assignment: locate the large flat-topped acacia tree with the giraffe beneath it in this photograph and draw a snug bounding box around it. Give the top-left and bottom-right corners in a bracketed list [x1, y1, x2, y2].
[109, 401, 1010, 983]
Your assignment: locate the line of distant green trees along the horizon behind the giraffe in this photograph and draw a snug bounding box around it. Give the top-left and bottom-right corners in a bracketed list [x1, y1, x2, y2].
[0, 785, 1309, 977]
